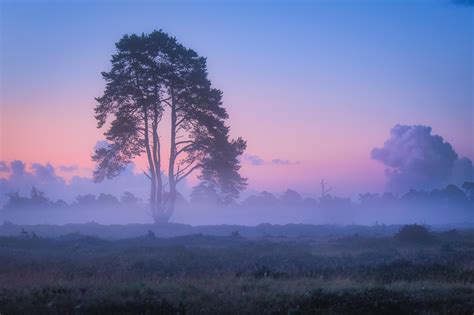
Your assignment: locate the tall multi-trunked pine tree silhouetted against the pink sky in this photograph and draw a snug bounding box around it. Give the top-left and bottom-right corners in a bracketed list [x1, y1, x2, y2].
[92, 31, 246, 223]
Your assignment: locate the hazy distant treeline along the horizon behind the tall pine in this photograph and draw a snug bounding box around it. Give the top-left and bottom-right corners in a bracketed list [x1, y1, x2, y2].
[3, 182, 474, 210]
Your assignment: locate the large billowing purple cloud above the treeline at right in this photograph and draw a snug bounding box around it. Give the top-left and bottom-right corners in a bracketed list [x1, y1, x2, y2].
[371, 125, 473, 192]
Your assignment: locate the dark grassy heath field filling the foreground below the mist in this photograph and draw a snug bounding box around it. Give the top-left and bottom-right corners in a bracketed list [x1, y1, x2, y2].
[0, 226, 474, 315]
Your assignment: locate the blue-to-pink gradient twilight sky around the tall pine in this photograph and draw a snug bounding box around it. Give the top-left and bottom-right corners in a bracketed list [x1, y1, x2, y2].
[0, 0, 474, 200]
